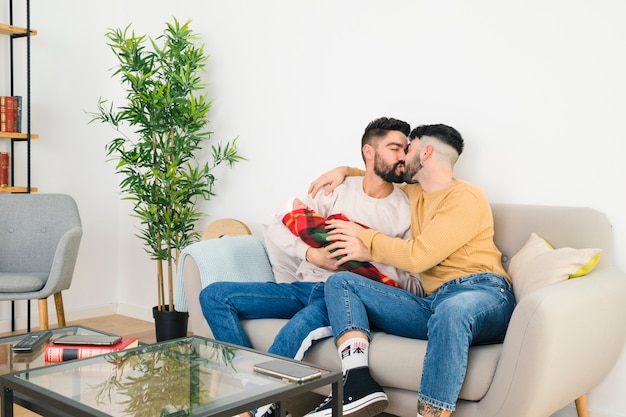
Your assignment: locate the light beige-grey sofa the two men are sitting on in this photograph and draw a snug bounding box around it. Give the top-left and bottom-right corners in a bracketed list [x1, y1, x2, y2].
[179, 204, 626, 417]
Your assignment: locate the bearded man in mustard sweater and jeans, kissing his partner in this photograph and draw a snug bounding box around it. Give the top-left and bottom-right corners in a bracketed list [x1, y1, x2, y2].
[307, 125, 515, 417]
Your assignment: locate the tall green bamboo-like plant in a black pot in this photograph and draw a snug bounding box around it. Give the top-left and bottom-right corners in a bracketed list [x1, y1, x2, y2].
[90, 18, 245, 341]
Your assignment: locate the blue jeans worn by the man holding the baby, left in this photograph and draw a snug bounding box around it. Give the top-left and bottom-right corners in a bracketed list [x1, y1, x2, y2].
[200, 282, 332, 360]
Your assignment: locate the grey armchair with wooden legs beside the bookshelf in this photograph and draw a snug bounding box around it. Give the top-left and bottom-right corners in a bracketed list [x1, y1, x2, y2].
[0, 193, 83, 330]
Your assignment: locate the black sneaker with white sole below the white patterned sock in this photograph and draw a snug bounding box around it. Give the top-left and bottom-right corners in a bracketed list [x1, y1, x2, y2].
[305, 367, 389, 417]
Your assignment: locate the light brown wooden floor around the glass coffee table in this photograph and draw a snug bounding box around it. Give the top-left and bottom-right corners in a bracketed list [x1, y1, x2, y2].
[0, 315, 330, 417]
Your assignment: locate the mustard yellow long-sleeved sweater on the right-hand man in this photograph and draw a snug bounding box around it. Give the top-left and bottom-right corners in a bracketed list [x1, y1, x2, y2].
[351, 170, 510, 294]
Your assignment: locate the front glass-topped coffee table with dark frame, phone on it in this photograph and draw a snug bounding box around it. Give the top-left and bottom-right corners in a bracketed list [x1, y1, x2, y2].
[0, 336, 343, 417]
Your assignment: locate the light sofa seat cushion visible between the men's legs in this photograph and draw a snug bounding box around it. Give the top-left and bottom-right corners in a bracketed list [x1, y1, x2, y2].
[242, 319, 502, 401]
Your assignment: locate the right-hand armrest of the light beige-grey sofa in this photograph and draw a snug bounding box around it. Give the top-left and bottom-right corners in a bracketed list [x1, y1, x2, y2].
[461, 266, 626, 417]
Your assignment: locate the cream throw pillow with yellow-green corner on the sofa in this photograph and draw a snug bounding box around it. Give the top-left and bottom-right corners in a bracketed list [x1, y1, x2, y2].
[508, 233, 602, 302]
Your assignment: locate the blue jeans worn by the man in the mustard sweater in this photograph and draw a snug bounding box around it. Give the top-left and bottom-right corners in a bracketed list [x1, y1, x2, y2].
[325, 272, 515, 410]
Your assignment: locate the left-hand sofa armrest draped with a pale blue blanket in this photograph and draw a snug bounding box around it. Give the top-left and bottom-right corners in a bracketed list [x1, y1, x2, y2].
[174, 235, 274, 337]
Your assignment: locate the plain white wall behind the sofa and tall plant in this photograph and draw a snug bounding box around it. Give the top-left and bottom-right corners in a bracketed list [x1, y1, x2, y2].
[0, 0, 626, 417]
